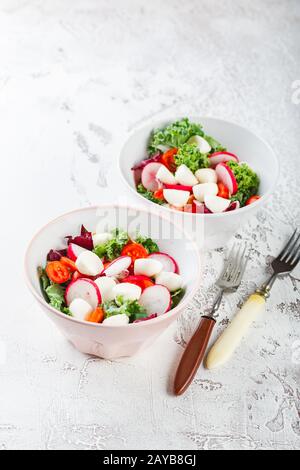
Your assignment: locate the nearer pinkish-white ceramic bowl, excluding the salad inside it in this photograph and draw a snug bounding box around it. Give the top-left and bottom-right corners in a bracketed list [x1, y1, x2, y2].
[25, 205, 200, 358]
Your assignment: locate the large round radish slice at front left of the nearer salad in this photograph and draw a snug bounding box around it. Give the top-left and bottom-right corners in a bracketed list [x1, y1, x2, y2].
[65, 277, 102, 309]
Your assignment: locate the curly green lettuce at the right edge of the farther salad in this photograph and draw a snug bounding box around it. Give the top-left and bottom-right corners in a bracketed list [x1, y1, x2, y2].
[226, 160, 259, 206]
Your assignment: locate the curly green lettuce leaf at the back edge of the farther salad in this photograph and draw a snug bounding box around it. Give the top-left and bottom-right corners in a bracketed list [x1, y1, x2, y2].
[148, 118, 204, 155]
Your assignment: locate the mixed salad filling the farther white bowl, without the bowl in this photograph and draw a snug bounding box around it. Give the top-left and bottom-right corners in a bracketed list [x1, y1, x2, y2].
[131, 118, 260, 214]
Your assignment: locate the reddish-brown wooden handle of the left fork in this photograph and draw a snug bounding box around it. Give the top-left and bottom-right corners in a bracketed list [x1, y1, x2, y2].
[174, 316, 216, 395]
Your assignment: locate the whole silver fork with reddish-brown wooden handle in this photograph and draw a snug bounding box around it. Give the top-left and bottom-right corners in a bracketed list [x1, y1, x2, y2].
[174, 245, 248, 395]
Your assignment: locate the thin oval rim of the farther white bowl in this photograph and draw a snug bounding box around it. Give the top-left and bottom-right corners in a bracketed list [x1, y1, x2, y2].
[118, 116, 280, 219]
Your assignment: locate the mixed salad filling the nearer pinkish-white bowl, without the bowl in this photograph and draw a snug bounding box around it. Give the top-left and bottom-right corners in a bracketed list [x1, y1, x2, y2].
[38, 224, 185, 326]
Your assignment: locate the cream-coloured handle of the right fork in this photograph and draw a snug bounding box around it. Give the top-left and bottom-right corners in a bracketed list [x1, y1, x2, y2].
[205, 293, 266, 369]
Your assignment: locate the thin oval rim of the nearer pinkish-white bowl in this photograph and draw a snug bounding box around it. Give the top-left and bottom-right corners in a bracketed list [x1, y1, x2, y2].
[24, 203, 201, 330]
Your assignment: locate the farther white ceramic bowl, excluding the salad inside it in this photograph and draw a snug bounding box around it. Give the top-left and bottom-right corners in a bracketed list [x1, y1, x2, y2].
[119, 116, 279, 249]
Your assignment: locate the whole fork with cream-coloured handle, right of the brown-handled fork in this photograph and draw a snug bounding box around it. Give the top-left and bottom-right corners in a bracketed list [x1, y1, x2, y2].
[205, 229, 300, 369]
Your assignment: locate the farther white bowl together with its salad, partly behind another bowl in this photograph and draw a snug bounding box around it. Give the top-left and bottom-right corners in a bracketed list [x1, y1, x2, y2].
[119, 117, 278, 248]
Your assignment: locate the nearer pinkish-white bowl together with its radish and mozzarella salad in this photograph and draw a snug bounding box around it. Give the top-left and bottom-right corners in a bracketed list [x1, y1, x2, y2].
[25, 205, 200, 358]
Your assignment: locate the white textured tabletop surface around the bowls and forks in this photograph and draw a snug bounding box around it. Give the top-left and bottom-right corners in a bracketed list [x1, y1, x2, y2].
[0, 0, 300, 449]
